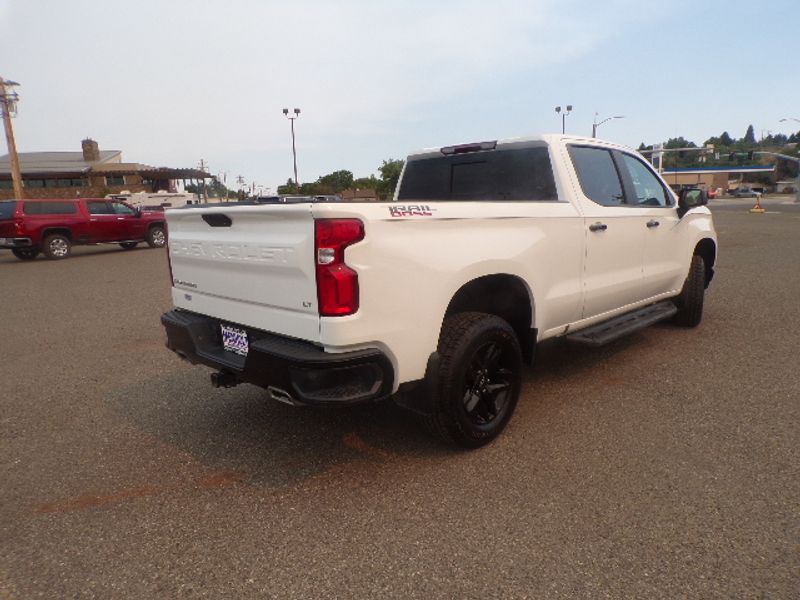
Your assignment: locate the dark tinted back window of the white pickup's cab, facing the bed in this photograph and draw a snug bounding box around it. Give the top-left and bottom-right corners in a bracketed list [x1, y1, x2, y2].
[398, 146, 558, 201]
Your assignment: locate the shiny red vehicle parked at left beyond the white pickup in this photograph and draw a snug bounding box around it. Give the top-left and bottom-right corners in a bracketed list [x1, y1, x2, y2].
[0, 198, 166, 260]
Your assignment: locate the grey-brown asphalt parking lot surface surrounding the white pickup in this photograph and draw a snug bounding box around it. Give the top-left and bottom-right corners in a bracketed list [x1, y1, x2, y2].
[0, 198, 800, 599]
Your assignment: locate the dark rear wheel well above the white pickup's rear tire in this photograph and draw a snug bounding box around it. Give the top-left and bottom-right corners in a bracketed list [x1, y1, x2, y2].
[445, 274, 536, 362]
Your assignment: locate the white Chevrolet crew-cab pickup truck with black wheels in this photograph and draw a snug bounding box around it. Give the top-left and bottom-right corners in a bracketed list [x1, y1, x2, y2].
[162, 135, 717, 448]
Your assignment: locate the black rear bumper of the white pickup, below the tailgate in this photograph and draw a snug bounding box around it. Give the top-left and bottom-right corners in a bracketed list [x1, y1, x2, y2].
[161, 310, 394, 404]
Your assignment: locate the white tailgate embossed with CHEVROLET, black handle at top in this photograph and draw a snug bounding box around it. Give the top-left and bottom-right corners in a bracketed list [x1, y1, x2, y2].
[166, 204, 319, 341]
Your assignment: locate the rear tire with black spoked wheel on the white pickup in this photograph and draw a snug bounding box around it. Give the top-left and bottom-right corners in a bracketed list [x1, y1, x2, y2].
[426, 312, 522, 448]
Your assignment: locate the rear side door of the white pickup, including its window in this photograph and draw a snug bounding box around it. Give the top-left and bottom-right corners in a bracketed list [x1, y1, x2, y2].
[568, 145, 647, 319]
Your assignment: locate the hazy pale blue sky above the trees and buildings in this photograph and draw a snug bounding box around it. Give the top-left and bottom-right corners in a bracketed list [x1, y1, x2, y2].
[0, 0, 800, 190]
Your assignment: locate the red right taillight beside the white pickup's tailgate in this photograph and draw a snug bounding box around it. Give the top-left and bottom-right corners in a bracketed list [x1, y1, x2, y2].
[314, 219, 364, 317]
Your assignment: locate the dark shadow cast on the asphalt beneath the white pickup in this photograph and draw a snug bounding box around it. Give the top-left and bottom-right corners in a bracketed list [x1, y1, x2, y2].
[107, 336, 636, 488]
